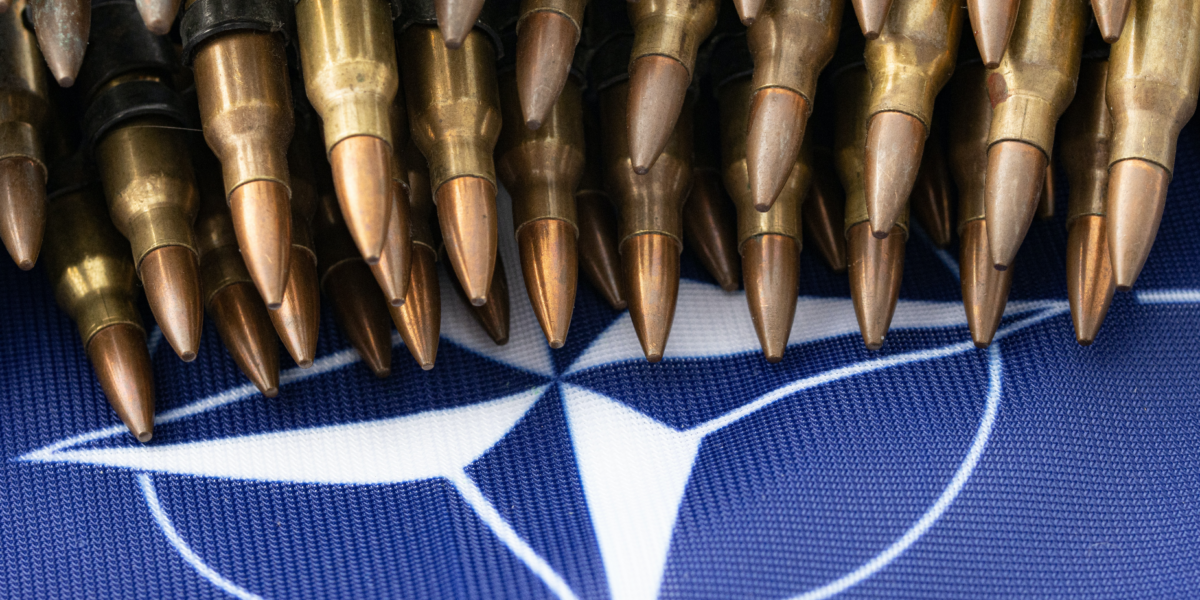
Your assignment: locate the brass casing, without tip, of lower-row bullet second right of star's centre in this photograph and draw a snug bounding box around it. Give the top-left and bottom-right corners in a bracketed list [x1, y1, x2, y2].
[718, 78, 812, 251]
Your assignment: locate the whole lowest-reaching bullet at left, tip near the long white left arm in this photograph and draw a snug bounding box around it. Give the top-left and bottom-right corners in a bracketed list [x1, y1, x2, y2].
[43, 154, 155, 443]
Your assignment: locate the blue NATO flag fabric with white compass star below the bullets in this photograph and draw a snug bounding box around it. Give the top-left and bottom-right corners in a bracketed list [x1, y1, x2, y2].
[0, 118, 1200, 600]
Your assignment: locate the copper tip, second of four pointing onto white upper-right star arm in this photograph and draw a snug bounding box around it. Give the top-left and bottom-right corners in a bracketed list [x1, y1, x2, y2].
[742, 234, 800, 362]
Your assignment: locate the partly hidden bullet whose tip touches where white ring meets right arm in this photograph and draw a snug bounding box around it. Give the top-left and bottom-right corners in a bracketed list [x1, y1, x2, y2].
[946, 57, 1013, 348]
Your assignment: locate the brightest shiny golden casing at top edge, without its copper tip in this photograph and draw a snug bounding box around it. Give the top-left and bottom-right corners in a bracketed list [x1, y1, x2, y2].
[296, 0, 400, 152]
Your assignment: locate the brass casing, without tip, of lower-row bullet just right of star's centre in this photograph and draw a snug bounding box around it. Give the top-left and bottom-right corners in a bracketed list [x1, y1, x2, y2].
[600, 80, 692, 252]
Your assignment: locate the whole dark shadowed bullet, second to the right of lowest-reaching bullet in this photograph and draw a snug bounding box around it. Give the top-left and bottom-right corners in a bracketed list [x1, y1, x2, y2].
[192, 144, 280, 398]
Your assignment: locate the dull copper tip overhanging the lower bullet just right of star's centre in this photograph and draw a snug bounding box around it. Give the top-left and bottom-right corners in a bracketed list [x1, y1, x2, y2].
[628, 54, 691, 175]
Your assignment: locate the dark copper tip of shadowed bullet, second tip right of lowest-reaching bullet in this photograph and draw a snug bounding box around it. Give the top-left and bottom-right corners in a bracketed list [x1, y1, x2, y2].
[209, 282, 280, 398]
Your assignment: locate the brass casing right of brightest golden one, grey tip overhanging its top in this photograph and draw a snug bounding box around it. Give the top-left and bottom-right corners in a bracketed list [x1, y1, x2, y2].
[401, 25, 500, 194]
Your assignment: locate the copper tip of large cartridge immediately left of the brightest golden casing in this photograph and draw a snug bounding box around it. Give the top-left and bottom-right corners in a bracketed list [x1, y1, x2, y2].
[229, 180, 292, 311]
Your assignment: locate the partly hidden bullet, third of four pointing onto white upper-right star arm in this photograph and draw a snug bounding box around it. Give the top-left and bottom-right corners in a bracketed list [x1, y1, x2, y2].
[834, 66, 908, 350]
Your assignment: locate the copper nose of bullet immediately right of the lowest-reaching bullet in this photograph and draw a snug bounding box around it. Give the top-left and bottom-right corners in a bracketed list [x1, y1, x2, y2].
[139, 246, 204, 362]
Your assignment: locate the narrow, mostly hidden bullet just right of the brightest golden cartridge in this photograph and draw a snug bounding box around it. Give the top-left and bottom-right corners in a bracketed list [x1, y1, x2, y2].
[388, 140, 442, 371]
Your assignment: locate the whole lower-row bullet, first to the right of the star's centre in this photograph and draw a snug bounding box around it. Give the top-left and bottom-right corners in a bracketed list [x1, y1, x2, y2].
[600, 79, 692, 362]
